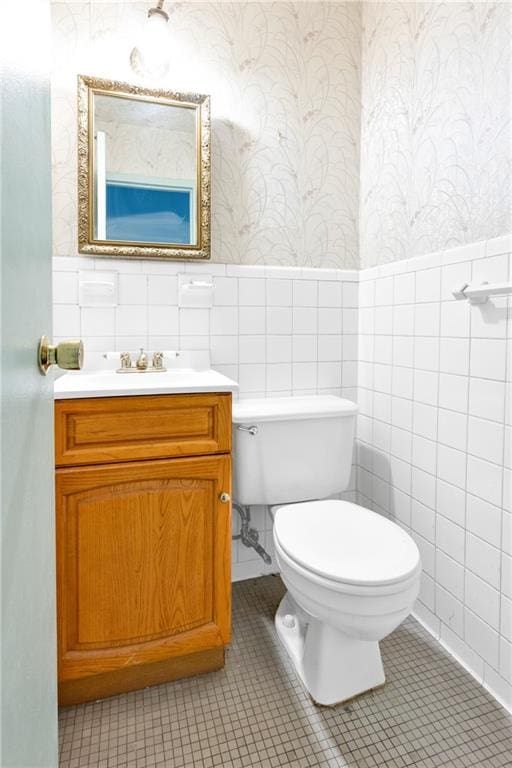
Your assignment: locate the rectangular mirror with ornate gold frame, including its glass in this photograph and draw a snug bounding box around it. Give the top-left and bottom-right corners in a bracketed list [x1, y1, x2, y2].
[78, 75, 211, 259]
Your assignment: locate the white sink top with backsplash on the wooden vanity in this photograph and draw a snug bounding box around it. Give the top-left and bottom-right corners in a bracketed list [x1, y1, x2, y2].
[54, 350, 238, 400]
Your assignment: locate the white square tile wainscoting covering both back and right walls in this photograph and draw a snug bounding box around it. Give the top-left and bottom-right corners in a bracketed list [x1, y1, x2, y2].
[54, 237, 512, 708]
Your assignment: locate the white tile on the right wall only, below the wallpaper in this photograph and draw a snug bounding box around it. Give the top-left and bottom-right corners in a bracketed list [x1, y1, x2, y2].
[357, 237, 512, 707]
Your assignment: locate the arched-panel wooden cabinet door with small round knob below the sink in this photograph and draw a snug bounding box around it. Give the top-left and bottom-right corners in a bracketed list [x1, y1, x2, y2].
[57, 456, 231, 701]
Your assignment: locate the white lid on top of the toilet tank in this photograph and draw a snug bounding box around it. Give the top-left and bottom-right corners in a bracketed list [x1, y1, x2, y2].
[233, 395, 357, 424]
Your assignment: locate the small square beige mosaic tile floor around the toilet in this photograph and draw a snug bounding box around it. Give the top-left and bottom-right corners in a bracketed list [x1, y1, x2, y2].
[60, 576, 512, 768]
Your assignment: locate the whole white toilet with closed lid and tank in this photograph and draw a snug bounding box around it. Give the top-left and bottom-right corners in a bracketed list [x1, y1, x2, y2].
[233, 395, 421, 705]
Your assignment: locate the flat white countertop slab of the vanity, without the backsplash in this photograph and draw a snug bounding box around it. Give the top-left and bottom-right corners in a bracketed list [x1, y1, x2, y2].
[54, 368, 238, 400]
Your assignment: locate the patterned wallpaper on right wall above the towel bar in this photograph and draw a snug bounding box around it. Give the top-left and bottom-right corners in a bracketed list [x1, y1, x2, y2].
[360, 2, 512, 268]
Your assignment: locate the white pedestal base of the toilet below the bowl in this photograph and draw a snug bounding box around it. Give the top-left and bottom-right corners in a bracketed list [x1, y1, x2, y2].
[275, 592, 385, 706]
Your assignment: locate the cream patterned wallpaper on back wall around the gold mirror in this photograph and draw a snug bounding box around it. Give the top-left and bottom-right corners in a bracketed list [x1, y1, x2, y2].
[48, 0, 361, 268]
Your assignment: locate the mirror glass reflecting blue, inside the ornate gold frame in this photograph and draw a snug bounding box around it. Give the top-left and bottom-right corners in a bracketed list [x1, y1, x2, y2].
[93, 93, 198, 245]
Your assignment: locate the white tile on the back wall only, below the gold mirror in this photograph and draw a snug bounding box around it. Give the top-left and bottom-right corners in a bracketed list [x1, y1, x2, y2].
[54, 257, 359, 579]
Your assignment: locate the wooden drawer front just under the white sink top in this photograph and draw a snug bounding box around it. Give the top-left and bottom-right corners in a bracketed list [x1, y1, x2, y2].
[55, 394, 231, 467]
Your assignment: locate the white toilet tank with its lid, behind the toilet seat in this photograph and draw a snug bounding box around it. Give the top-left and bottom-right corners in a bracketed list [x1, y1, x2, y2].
[233, 395, 357, 505]
